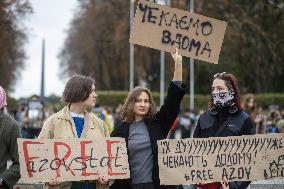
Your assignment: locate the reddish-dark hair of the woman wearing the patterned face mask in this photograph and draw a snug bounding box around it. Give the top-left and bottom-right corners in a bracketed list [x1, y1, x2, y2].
[209, 72, 243, 110]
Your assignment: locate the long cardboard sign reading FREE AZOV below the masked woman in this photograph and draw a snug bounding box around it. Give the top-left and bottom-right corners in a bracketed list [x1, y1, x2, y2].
[158, 134, 284, 185]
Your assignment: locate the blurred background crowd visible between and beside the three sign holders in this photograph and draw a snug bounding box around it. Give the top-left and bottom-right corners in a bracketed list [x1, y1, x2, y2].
[6, 94, 284, 139]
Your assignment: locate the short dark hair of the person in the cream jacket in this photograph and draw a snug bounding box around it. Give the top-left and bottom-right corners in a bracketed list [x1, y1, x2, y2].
[63, 75, 95, 103]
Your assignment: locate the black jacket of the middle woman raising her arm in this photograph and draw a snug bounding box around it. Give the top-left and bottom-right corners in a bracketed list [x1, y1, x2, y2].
[110, 82, 185, 189]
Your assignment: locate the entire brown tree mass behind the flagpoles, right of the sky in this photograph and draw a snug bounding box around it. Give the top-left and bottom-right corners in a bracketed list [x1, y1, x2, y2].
[60, 0, 284, 94]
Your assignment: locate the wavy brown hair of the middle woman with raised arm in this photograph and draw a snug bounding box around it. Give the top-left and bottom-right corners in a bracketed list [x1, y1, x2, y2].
[120, 87, 156, 123]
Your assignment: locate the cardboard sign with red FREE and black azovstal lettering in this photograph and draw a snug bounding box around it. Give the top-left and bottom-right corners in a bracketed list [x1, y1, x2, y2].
[18, 138, 130, 182]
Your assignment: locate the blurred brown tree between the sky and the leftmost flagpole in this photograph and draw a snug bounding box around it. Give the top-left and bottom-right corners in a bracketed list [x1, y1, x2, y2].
[59, 0, 129, 89]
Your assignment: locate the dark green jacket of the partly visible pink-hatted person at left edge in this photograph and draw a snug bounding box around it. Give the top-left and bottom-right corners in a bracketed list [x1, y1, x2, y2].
[0, 110, 21, 188]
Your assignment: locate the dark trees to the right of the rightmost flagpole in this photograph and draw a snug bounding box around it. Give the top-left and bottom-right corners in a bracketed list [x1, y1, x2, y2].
[193, 0, 284, 93]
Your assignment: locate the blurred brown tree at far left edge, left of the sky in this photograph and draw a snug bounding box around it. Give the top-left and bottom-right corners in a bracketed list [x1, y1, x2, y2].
[0, 0, 32, 89]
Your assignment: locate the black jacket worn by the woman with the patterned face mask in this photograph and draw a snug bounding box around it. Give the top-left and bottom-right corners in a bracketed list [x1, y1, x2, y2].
[193, 108, 256, 189]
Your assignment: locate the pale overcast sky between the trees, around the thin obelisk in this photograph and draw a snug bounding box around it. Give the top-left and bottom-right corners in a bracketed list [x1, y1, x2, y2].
[11, 0, 78, 98]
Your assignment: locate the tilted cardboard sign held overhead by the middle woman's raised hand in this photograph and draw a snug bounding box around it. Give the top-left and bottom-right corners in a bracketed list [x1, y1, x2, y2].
[129, 0, 227, 64]
